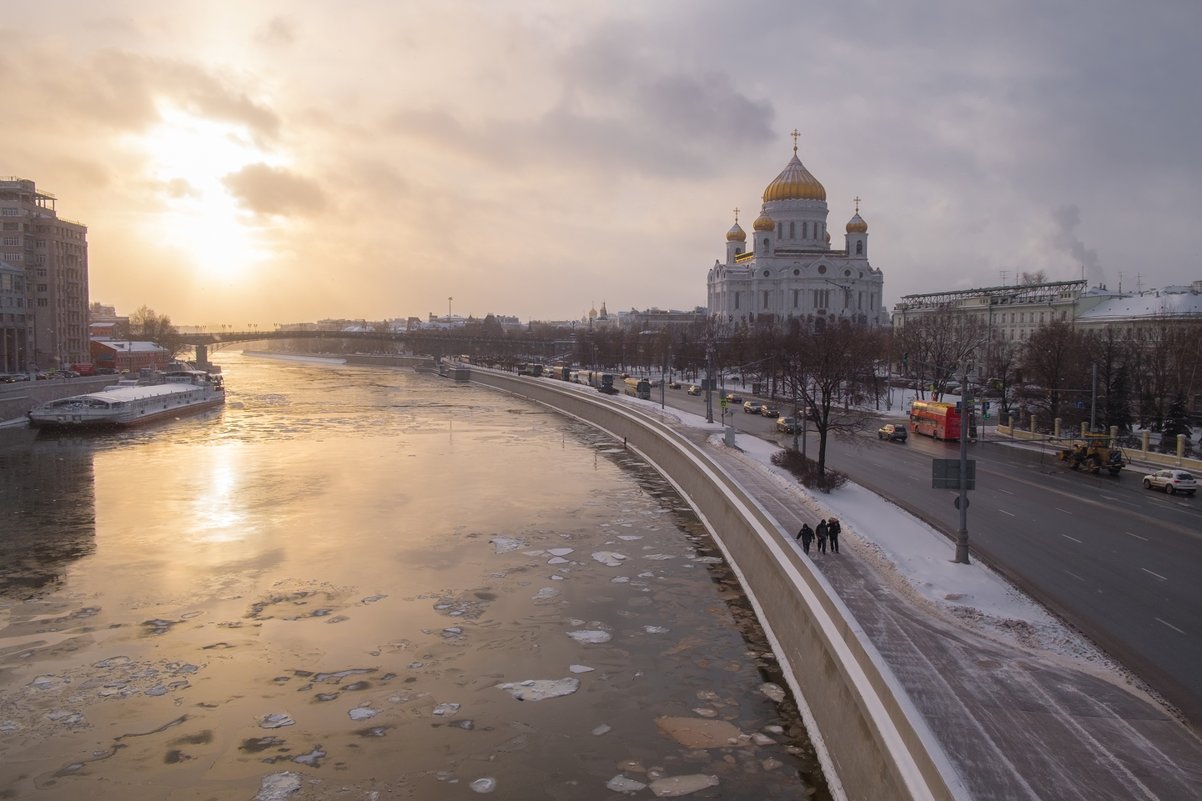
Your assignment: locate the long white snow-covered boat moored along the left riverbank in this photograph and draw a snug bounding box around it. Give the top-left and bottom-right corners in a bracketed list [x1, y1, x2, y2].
[29, 369, 225, 428]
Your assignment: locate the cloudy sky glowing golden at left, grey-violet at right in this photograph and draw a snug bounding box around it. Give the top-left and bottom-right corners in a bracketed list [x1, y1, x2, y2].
[0, 0, 1202, 328]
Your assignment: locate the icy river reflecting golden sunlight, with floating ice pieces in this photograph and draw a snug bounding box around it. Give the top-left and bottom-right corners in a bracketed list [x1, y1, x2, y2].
[0, 354, 829, 801]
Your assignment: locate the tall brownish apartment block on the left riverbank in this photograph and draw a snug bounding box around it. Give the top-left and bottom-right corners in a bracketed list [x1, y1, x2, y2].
[0, 178, 90, 369]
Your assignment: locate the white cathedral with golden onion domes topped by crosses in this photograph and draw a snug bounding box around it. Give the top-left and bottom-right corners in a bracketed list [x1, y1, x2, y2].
[706, 131, 889, 326]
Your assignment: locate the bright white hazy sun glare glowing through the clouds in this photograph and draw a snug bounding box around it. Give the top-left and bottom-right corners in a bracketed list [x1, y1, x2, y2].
[137, 106, 273, 280]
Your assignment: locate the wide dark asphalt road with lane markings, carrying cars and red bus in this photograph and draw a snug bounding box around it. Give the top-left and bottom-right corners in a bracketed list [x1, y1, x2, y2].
[651, 387, 1202, 730]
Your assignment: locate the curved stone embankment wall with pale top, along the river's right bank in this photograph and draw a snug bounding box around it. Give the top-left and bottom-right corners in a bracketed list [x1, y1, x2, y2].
[471, 367, 966, 801]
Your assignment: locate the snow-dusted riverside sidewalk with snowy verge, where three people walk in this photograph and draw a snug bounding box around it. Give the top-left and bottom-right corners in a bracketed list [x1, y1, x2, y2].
[680, 423, 1202, 801]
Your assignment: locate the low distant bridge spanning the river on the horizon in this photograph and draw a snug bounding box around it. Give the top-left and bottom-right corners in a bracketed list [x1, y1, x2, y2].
[175, 330, 575, 364]
